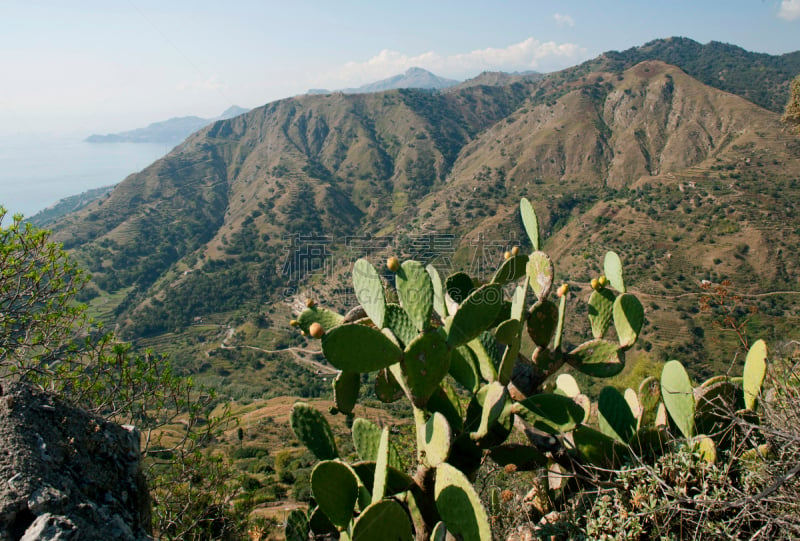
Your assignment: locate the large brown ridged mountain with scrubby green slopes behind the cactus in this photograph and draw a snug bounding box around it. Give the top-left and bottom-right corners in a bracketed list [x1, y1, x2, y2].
[47, 40, 800, 392]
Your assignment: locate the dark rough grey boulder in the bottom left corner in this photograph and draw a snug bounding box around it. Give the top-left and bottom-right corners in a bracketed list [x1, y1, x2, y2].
[0, 383, 152, 541]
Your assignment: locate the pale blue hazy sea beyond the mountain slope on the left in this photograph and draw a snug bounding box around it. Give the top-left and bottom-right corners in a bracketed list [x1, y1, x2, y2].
[0, 134, 172, 217]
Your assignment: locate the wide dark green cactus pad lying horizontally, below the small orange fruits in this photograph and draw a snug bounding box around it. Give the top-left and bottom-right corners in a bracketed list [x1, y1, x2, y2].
[322, 324, 403, 373]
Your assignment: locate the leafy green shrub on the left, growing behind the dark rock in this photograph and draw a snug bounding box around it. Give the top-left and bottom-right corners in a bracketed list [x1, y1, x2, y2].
[0, 206, 246, 539]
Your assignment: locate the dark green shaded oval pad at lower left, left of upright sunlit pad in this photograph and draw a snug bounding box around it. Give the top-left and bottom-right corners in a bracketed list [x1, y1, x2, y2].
[311, 460, 358, 529]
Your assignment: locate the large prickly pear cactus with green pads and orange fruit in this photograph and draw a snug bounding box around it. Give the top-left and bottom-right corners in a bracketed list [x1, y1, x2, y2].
[286, 199, 766, 540]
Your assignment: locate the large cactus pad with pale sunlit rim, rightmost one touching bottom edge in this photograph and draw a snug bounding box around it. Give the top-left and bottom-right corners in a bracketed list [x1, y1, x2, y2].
[434, 462, 492, 541]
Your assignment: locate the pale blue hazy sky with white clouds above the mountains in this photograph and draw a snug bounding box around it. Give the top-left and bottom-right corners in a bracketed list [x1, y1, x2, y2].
[0, 0, 800, 135]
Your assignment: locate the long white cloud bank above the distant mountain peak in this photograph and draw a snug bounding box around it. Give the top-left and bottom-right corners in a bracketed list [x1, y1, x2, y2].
[319, 38, 586, 88]
